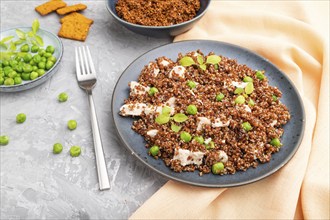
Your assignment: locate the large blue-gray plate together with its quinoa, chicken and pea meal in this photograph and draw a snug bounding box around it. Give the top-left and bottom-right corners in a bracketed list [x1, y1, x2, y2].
[112, 41, 305, 187]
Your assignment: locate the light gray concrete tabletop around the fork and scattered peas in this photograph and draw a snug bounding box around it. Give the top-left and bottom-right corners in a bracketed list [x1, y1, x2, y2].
[0, 0, 172, 219]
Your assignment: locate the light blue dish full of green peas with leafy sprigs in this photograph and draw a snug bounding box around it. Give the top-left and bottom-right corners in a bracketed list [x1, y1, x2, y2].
[0, 20, 63, 92]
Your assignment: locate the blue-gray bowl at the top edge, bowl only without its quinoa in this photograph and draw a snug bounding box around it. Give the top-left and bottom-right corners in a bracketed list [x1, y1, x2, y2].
[107, 0, 211, 38]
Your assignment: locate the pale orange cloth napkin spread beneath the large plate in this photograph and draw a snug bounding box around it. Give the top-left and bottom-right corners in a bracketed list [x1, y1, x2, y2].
[130, 1, 330, 219]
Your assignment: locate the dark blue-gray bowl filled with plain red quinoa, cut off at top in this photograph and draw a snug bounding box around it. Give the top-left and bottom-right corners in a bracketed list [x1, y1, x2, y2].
[107, 0, 211, 37]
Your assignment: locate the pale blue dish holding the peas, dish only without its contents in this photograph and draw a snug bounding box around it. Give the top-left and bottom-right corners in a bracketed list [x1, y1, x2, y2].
[0, 27, 63, 92]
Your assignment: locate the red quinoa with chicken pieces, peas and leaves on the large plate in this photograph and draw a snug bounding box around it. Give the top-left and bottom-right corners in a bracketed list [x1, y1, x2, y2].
[120, 50, 290, 175]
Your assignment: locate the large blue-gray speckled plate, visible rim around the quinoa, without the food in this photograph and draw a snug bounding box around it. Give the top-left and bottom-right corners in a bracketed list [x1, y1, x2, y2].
[112, 40, 305, 187]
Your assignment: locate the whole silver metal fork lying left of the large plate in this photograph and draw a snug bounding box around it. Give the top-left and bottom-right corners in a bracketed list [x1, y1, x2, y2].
[75, 46, 110, 190]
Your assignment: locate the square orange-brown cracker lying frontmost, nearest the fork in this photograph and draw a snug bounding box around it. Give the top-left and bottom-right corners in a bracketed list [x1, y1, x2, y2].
[58, 21, 91, 41]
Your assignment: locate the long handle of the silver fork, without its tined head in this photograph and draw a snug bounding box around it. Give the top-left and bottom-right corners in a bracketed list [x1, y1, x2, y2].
[87, 91, 110, 190]
